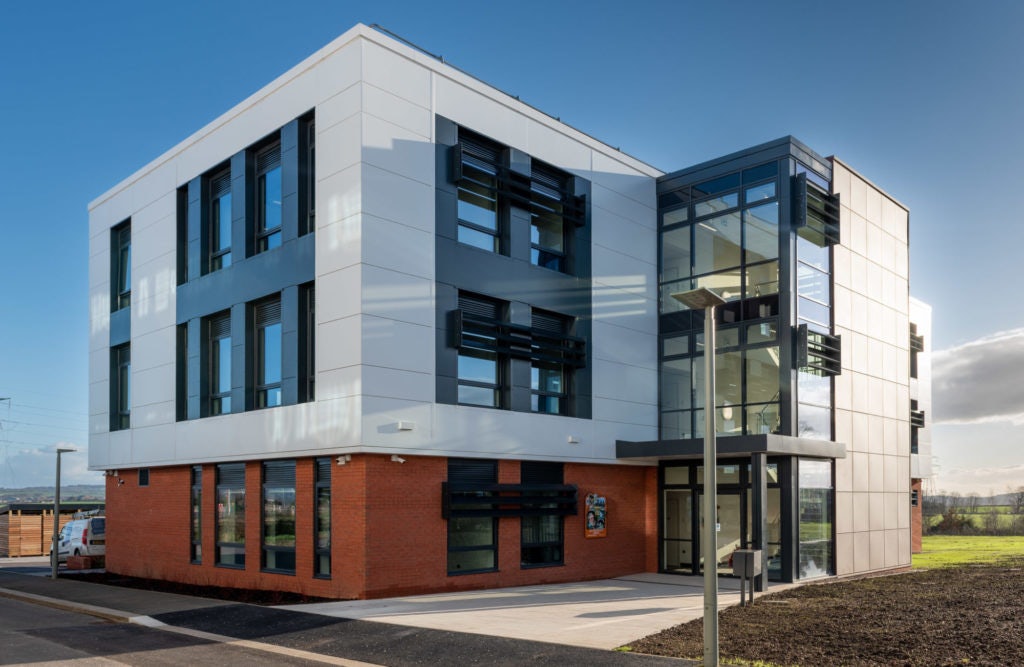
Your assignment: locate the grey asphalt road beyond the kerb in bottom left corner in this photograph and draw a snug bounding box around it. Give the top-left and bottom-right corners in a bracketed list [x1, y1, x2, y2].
[0, 597, 339, 667]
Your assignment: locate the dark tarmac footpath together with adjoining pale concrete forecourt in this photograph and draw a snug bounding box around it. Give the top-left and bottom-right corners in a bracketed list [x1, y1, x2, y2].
[0, 557, 790, 667]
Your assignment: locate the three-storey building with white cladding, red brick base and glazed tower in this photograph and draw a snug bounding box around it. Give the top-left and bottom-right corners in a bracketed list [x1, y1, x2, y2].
[89, 26, 927, 597]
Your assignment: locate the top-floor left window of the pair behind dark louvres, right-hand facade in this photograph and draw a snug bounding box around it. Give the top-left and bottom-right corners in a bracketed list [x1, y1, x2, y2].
[455, 130, 502, 252]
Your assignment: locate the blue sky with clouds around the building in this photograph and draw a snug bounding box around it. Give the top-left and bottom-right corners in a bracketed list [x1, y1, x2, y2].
[0, 0, 1024, 493]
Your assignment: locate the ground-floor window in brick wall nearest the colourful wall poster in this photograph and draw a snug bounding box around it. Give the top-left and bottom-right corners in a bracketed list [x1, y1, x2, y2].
[519, 461, 564, 568]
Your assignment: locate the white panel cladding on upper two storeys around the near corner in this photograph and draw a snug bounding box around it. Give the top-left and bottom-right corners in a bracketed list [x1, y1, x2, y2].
[89, 27, 659, 469]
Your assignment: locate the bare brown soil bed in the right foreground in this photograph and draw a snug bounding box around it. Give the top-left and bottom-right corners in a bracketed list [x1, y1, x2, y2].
[630, 556, 1024, 667]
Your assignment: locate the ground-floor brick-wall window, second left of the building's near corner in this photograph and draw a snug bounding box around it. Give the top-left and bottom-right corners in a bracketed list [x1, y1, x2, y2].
[263, 461, 295, 574]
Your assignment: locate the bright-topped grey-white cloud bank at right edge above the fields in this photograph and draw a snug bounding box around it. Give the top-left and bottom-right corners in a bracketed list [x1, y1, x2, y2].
[932, 329, 1024, 425]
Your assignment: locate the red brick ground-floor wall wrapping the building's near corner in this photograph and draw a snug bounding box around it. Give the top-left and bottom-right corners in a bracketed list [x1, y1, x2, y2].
[106, 455, 657, 598]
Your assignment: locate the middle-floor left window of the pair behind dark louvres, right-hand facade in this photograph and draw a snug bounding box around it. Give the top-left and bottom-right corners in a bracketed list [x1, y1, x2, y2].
[459, 294, 505, 408]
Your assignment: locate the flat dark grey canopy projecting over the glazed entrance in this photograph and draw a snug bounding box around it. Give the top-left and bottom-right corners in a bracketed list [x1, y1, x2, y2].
[615, 433, 846, 463]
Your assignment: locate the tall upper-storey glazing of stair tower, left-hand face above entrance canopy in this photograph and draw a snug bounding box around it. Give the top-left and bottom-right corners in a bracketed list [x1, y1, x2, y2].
[659, 162, 782, 439]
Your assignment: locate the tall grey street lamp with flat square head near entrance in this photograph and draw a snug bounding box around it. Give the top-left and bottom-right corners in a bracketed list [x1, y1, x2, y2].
[672, 287, 725, 667]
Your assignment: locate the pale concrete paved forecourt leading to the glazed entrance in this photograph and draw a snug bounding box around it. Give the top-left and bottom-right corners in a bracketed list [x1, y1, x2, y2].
[287, 573, 792, 649]
